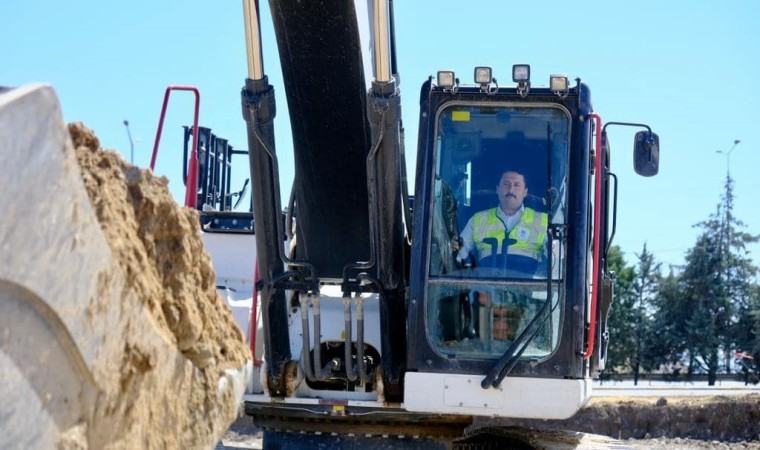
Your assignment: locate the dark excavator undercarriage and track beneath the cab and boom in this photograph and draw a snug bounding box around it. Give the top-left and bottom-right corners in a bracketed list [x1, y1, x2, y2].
[246, 403, 630, 450]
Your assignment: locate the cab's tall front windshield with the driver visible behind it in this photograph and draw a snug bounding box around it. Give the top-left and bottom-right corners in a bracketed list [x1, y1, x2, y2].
[426, 103, 570, 358]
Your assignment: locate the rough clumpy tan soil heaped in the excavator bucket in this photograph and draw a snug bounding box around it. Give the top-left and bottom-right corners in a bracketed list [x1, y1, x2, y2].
[69, 123, 250, 368]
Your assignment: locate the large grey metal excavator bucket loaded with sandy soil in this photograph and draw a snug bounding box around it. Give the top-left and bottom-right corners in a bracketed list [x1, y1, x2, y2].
[0, 85, 251, 449]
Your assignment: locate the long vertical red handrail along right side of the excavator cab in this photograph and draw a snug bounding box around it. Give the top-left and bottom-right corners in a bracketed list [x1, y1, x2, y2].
[583, 113, 603, 359]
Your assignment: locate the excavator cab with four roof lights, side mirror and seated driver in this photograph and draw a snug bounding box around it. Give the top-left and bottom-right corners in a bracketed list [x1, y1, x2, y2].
[404, 69, 659, 419]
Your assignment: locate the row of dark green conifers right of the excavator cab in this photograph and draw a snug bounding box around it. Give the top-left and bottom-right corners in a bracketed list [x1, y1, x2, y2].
[601, 176, 760, 385]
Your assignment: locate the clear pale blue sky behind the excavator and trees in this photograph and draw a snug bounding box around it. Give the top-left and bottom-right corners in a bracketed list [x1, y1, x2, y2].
[0, 0, 760, 267]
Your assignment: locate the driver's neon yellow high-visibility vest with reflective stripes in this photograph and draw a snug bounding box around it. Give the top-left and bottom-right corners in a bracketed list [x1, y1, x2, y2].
[472, 208, 549, 260]
